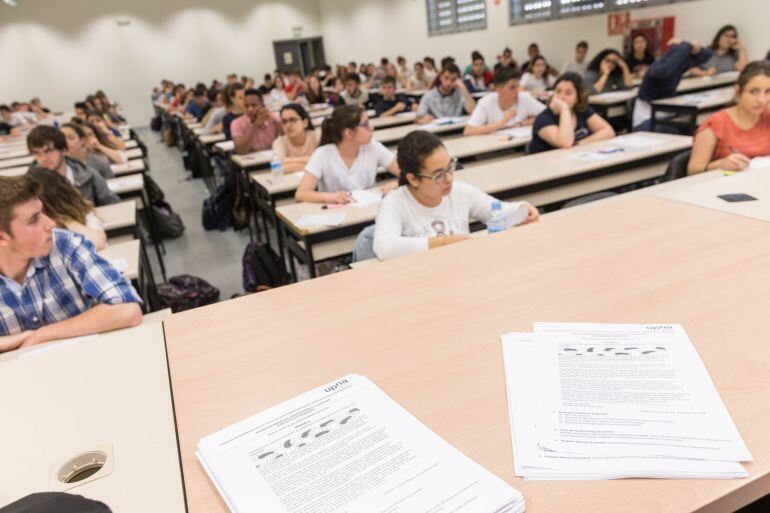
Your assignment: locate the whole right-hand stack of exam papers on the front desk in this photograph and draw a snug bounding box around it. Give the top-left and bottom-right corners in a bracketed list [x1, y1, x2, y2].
[502, 323, 752, 480]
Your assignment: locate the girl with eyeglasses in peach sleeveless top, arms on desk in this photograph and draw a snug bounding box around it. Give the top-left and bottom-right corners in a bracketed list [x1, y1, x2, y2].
[273, 103, 318, 173]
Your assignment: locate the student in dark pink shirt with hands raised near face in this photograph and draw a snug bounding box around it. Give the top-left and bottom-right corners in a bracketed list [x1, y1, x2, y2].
[230, 89, 283, 155]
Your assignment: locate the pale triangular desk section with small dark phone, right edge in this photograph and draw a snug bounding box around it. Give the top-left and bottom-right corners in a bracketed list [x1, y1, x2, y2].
[657, 169, 770, 222]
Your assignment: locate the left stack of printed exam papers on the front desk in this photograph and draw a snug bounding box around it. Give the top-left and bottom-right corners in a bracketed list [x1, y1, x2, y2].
[197, 374, 524, 513]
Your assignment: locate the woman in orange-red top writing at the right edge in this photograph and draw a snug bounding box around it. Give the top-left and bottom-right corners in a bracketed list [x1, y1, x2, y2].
[687, 61, 770, 174]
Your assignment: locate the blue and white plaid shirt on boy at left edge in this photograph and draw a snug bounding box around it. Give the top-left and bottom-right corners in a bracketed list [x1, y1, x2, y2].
[0, 229, 142, 335]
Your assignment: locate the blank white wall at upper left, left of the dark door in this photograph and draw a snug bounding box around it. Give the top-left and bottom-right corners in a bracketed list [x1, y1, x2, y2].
[0, 0, 321, 126]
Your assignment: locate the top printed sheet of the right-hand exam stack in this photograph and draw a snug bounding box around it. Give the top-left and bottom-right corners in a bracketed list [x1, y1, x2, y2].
[534, 323, 752, 461]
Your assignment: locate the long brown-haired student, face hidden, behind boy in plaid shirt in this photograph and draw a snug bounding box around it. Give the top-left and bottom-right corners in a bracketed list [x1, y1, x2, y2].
[27, 167, 107, 251]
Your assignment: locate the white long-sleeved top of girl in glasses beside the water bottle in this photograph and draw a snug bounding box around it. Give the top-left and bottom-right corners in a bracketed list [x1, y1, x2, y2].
[374, 181, 522, 260]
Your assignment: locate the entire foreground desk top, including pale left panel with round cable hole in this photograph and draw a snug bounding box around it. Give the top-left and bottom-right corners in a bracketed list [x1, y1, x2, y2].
[0, 168, 770, 513]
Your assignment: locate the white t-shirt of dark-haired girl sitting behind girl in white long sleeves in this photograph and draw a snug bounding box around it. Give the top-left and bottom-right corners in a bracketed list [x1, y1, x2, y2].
[305, 141, 396, 192]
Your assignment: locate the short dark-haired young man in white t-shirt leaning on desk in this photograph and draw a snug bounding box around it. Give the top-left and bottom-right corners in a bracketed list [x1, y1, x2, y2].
[463, 66, 545, 135]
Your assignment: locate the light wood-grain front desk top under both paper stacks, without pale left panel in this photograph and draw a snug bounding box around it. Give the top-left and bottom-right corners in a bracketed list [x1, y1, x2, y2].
[165, 197, 770, 513]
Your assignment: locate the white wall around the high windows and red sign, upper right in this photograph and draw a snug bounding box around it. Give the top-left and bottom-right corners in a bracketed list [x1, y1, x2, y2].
[319, 0, 770, 75]
